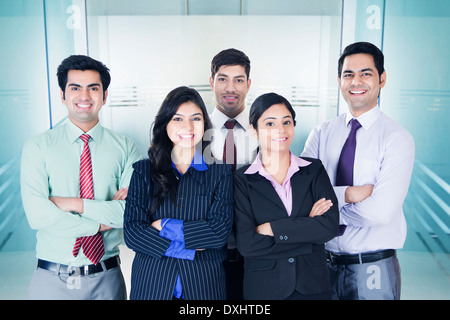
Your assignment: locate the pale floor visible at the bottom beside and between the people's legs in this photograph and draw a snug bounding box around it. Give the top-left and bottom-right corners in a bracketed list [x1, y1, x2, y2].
[0, 247, 450, 300]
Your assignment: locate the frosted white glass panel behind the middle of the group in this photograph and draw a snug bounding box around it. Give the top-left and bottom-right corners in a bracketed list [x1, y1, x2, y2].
[87, 0, 341, 154]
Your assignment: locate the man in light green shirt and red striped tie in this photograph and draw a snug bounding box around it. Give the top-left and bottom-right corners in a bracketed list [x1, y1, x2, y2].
[21, 56, 140, 299]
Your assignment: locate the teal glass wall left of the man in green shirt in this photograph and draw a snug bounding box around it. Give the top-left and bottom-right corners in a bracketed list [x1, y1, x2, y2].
[0, 0, 93, 251]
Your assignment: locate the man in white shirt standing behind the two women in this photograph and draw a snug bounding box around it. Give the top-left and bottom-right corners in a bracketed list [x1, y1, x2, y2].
[205, 48, 258, 300]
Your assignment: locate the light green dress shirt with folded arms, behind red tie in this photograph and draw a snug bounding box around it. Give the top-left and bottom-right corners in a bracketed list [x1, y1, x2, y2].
[21, 121, 140, 266]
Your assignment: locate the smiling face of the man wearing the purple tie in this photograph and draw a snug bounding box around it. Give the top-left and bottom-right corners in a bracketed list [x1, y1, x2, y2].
[338, 53, 386, 117]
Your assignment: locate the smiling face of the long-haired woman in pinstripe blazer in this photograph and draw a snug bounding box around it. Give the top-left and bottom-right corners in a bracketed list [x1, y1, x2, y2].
[166, 101, 204, 149]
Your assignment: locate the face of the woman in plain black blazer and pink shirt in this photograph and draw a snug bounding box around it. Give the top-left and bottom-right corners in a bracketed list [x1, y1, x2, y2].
[251, 103, 294, 154]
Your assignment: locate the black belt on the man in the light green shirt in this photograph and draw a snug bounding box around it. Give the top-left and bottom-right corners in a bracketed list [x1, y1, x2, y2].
[38, 256, 120, 276]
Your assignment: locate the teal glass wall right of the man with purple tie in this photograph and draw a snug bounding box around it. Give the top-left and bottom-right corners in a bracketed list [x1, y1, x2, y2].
[381, 0, 450, 258]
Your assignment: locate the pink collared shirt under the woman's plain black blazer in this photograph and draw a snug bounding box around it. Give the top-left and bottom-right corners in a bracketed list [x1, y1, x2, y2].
[244, 152, 311, 216]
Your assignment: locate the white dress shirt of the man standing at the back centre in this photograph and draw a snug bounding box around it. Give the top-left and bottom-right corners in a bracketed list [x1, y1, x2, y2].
[204, 108, 259, 169]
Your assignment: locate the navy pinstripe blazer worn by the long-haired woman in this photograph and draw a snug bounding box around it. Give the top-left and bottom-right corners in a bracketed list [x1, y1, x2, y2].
[124, 159, 233, 300]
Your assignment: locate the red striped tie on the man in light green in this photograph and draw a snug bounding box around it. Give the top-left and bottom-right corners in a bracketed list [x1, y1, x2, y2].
[72, 134, 105, 264]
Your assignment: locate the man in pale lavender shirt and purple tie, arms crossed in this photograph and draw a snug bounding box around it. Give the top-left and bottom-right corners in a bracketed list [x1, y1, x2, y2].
[302, 42, 415, 299]
